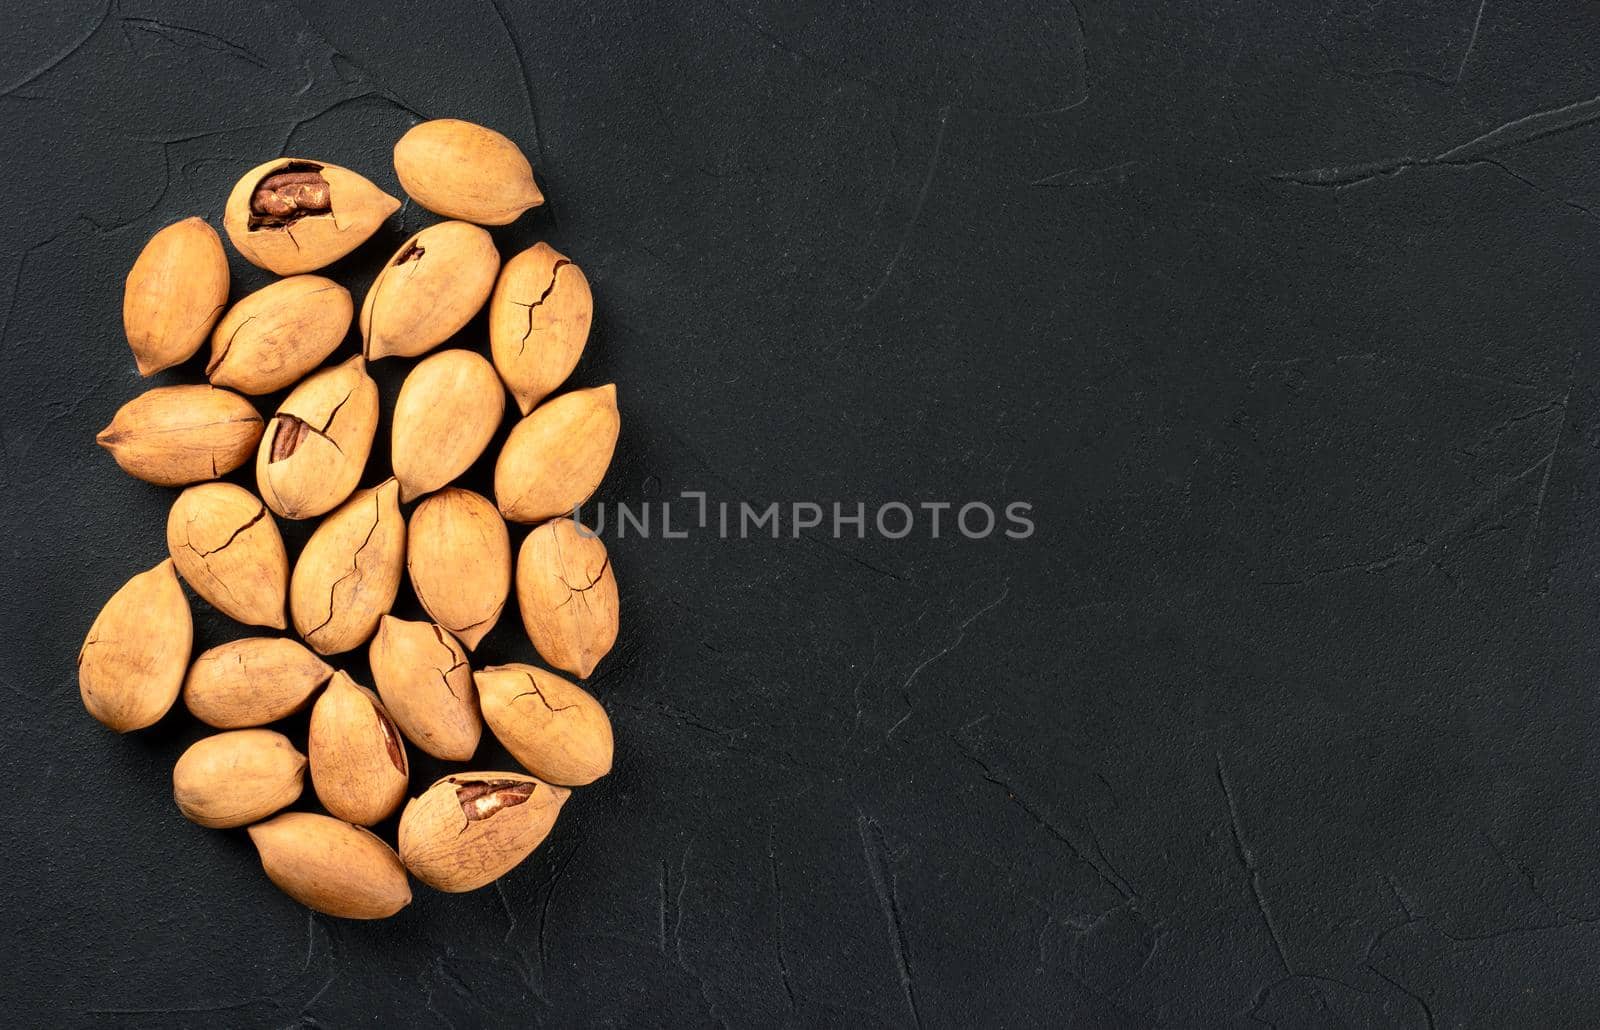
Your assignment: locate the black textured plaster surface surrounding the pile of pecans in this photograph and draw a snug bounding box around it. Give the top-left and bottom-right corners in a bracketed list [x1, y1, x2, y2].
[0, 0, 1600, 1027]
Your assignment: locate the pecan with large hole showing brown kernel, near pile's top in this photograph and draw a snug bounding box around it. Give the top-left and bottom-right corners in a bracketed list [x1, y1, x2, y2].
[222, 157, 400, 275]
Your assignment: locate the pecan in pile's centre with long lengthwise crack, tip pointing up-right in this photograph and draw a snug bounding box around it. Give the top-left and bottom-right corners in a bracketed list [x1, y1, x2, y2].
[290, 480, 405, 654]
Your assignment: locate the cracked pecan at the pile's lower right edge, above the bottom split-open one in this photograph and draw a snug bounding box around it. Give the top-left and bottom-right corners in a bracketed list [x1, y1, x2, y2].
[474, 665, 611, 787]
